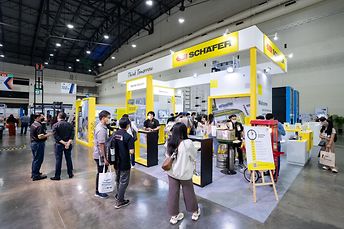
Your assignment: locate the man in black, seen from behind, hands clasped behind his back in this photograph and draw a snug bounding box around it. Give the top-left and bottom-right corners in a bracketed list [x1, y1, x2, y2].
[50, 112, 75, 180]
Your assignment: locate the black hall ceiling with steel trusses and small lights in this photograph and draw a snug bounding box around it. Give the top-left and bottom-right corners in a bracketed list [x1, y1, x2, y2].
[0, 0, 184, 73]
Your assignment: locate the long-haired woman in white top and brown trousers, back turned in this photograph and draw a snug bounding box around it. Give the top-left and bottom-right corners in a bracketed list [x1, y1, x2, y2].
[166, 123, 201, 224]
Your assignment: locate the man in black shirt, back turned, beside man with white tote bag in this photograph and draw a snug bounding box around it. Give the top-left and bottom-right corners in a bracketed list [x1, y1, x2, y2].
[113, 118, 134, 209]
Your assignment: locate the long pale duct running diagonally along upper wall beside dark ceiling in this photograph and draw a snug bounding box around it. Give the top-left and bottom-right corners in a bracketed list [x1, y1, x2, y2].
[96, 0, 323, 81]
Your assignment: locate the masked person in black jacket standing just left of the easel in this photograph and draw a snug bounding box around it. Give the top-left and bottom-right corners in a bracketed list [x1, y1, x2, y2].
[227, 114, 244, 167]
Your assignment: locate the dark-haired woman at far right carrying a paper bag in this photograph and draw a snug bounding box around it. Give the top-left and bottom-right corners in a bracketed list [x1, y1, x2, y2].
[319, 117, 338, 173]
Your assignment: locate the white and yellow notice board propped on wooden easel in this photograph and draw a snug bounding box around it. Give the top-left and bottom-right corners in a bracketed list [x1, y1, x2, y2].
[244, 126, 275, 170]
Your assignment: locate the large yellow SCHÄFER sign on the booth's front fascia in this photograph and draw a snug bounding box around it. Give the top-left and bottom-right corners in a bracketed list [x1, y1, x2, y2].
[172, 32, 239, 68]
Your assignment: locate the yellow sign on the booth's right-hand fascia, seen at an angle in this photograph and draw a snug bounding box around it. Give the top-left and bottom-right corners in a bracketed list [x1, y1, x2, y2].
[264, 35, 287, 71]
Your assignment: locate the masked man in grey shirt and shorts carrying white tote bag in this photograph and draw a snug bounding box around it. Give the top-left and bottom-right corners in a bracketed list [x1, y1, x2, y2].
[93, 110, 110, 198]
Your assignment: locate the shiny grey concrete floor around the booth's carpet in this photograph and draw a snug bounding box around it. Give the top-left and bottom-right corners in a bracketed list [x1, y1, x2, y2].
[0, 133, 344, 229]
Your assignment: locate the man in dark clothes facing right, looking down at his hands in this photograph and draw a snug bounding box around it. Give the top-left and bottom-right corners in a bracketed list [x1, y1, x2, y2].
[30, 114, 51, 181]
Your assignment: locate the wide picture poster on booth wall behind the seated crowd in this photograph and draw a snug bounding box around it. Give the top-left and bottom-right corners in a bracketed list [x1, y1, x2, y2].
[212, 97, 250, 123]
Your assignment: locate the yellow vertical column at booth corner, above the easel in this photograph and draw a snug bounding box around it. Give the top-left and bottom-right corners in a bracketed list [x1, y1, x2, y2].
[250, 48, 257, 120]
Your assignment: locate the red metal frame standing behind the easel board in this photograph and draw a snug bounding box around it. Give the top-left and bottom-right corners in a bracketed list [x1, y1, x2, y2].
[251, 120, 284, 182]
